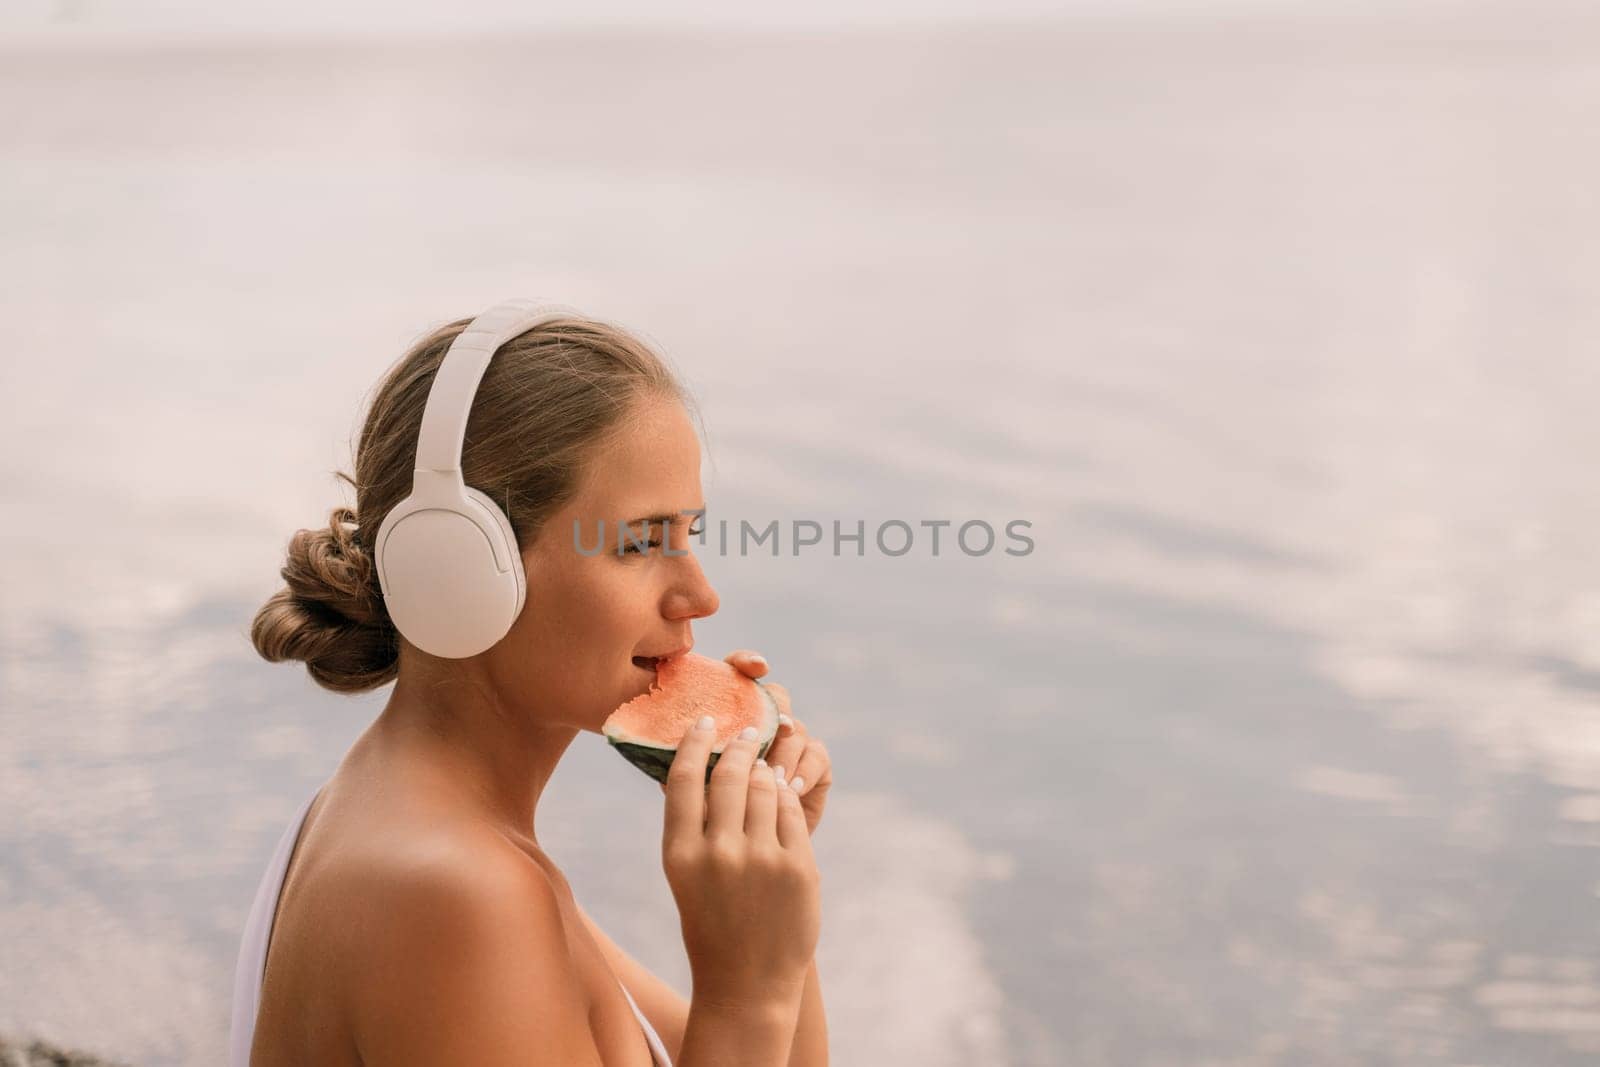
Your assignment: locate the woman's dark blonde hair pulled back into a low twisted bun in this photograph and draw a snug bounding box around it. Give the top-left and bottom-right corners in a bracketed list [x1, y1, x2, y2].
[250, 315, 698, 693]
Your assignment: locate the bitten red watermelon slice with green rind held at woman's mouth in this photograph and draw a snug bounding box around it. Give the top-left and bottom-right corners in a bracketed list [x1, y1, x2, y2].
[600, 653, 778, 782]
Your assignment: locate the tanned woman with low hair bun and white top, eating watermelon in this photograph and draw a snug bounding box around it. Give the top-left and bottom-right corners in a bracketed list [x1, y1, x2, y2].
[241, 306, 832, 1067]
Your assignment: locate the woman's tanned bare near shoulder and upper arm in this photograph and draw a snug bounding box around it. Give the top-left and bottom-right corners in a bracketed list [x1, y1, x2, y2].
[340, 825, 600, 1067]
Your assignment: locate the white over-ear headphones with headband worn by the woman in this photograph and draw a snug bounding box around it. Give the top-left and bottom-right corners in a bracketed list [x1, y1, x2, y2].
[373, 301, 579, 659]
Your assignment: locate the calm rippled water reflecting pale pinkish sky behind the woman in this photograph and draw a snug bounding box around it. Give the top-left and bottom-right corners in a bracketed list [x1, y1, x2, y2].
[0, 5, 1600, 1067]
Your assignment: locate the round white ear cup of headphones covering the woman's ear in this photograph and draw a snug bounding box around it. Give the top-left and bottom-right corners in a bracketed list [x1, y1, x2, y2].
[376, 490, 525, 659]
